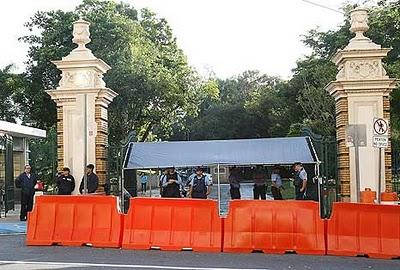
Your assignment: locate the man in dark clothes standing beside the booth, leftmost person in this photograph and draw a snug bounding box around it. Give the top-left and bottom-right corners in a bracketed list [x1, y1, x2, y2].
[15, 165, 37, 221]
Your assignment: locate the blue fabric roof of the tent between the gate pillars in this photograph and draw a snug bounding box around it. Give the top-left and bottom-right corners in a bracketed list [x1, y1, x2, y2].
[124, 137, 317, 169]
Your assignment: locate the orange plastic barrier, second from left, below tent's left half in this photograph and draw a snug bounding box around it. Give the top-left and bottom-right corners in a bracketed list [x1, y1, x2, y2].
[122, 198, 222, 252]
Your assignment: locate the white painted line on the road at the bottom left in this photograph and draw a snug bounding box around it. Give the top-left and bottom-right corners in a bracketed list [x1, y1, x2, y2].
[0, 261, 268, 270]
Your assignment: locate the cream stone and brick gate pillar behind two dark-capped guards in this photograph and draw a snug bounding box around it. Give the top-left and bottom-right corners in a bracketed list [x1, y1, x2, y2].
[46, 19, 117, 194]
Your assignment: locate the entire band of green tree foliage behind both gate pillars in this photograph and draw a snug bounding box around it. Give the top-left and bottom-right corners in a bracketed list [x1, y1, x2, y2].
[0, 0, 400, 152]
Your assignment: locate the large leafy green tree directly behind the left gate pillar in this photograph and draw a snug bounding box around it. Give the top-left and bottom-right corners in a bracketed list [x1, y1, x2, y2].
[21, 0, 204, 143]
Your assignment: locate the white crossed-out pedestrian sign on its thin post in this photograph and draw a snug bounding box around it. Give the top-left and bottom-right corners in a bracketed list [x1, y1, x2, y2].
[373, 118, 389, 204]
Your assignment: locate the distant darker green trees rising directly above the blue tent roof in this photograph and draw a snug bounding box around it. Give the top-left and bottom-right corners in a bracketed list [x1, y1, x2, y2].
[171, 71, 288, 140]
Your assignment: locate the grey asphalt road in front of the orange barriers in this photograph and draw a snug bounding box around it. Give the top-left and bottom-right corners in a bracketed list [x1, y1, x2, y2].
[0, 235, 400, 270]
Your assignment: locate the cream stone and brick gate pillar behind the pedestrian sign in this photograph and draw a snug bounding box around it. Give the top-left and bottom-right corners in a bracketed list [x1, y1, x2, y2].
[326, 8, 396, 201]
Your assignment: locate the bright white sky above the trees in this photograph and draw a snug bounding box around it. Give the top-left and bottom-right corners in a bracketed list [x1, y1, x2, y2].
[0, 0, 358, 78]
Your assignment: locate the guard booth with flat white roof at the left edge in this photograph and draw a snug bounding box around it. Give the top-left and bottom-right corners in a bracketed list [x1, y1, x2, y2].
[0, 121, 46, 216]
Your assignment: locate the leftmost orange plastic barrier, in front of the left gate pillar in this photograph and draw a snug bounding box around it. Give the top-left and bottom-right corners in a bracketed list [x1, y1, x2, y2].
[26, 195, 123, 247]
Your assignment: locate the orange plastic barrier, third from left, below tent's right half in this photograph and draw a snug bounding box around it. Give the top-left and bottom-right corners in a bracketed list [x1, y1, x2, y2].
[223, 200, 326, 254]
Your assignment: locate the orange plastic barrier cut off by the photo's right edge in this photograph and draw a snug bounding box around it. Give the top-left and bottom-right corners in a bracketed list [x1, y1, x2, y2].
[327, 203, 400, 258]
